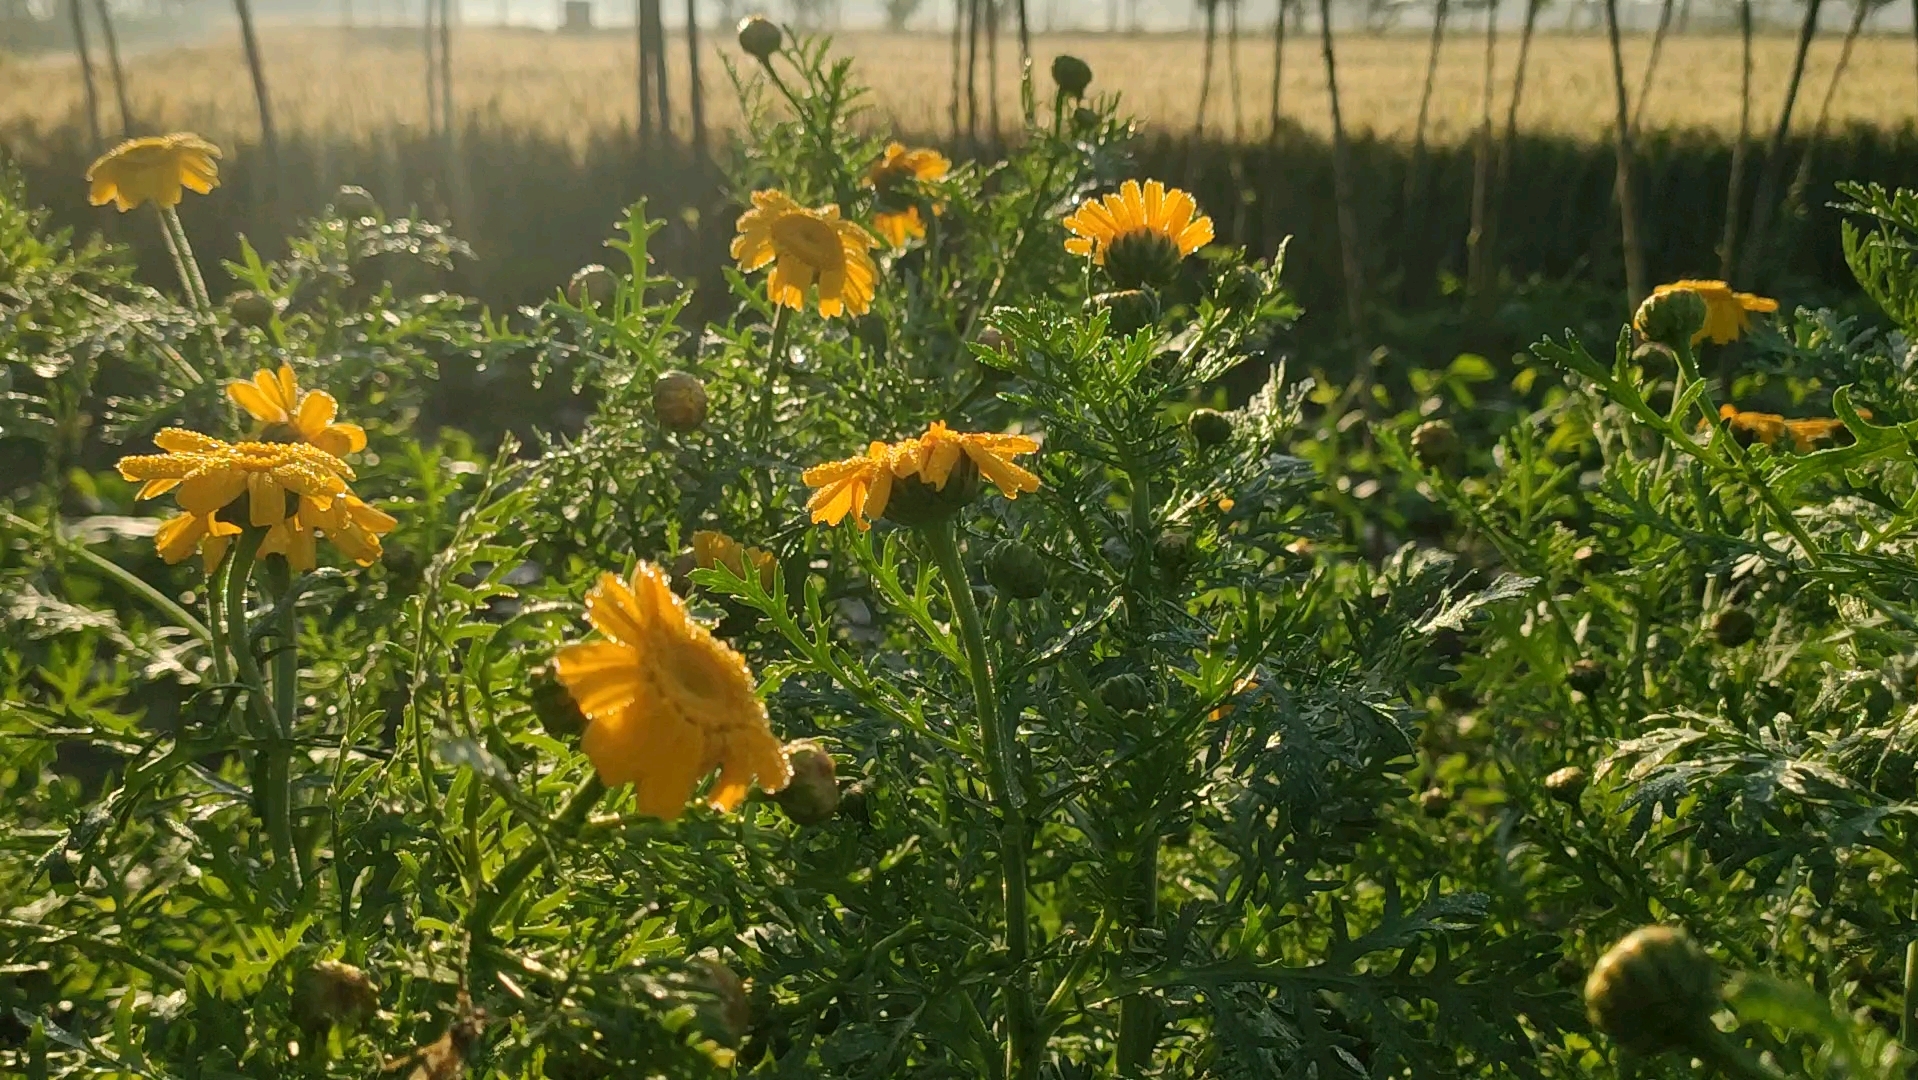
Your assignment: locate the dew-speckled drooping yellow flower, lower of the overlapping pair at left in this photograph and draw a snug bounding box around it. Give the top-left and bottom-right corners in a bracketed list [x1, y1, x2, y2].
[119, 428, 397, 570]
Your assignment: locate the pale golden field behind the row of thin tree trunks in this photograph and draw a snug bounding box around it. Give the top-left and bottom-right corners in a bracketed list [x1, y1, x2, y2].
[0, 27, 1918, 155]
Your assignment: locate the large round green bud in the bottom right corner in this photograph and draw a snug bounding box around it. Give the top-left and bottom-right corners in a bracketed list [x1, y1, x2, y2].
[1584, 927, 1719, 1057]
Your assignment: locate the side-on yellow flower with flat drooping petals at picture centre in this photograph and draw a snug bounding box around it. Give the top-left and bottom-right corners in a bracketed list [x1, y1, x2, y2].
[802, 420, 1040, 529]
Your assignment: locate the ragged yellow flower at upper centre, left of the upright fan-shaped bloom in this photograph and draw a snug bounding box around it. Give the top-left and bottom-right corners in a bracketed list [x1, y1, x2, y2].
[733, 192, 878, 317]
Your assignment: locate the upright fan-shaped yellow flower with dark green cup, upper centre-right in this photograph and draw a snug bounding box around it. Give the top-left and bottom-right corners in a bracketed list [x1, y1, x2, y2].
[1064, 180, 1212, 288]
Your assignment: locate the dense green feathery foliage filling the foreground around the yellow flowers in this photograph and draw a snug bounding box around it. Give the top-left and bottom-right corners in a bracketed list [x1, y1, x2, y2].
[11, 25, 1918, 1080]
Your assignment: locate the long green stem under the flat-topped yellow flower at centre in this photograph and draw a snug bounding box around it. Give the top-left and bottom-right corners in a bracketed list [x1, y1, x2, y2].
[923, 520, 1040, 1080]
